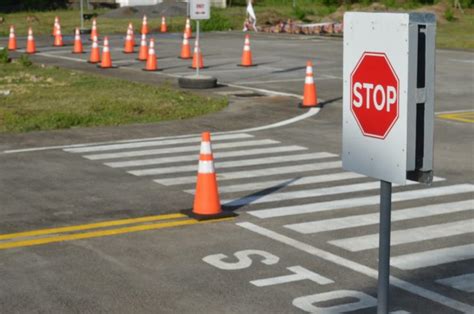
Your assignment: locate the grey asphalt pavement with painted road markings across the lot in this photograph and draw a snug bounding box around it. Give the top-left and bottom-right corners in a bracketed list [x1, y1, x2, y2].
[0, 33, 474, 314]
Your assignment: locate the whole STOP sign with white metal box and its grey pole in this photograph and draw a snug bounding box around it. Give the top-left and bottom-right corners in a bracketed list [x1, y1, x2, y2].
[342, 12, 436, 314]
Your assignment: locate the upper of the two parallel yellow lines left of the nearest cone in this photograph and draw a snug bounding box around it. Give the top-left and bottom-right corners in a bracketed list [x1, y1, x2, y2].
[0, 214, 187, 240]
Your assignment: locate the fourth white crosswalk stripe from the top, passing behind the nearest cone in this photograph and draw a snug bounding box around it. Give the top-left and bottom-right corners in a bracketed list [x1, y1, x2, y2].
[128, 153, 337, 176]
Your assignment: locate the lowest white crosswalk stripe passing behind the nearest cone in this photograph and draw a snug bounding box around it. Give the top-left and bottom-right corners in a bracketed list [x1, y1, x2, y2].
[185, 172, 366, 194]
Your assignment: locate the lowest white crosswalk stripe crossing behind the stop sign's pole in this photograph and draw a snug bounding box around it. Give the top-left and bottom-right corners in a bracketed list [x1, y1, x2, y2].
[328, 219, 474, 252]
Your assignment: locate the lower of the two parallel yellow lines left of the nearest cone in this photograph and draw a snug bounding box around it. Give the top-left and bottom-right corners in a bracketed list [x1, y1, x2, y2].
[0, 218, 233, 250]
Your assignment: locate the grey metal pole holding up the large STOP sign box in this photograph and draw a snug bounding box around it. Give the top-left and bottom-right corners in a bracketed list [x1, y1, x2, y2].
[377, 181, 392, 314]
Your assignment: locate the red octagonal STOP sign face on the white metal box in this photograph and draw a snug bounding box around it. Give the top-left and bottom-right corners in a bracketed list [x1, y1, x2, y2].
[350, 52, 399, 139]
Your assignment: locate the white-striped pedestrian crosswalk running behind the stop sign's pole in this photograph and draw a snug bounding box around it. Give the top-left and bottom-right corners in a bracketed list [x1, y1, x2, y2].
[64, 133, 474, 298]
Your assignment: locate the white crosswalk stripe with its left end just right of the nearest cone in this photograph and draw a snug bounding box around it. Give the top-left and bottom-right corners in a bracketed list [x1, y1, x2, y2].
[222, 181, 417, 206]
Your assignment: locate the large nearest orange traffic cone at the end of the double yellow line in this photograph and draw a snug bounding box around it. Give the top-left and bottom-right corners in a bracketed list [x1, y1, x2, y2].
[183, 132, 235, 220]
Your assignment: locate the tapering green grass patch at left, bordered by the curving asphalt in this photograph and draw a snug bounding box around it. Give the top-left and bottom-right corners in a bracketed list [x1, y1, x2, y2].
[0, 62, 227, 132]
